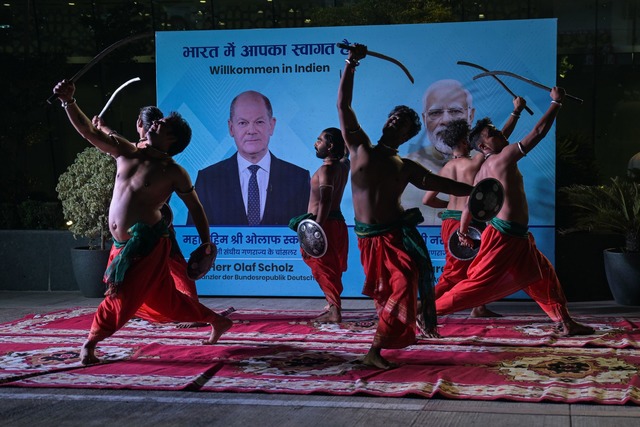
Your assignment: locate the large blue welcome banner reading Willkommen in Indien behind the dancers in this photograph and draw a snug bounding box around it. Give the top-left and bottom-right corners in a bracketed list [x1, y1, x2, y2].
[156, 19, 557, 297]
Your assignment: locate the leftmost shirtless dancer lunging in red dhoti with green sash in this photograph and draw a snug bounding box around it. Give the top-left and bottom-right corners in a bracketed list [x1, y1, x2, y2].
[53, 80, 233, 365]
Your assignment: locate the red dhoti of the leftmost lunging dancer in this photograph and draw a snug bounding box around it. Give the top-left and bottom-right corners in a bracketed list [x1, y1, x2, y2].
[89, 237, 220, 341]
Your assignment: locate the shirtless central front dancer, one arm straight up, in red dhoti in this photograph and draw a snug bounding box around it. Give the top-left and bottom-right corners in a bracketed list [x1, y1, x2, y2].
[337, 45, 472, 369]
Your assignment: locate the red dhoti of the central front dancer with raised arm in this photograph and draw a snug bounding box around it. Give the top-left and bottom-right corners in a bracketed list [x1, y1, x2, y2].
[358, 229, 418, 348]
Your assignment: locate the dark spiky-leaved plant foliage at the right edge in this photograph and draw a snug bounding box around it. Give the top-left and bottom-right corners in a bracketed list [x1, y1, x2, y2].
[559, 177, 640, 252]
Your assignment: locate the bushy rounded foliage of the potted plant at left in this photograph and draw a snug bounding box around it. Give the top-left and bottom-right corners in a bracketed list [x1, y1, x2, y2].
[56, 147, 116, 249]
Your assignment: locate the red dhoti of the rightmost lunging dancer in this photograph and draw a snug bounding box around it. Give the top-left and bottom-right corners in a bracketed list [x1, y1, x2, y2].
[436, 225, 570, 322]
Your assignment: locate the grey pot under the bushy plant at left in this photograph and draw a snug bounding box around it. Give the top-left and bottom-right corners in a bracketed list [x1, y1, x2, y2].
[71, 246, 109, 298]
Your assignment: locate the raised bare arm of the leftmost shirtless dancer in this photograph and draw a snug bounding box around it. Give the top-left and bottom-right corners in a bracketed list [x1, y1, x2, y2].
[53, 80, 136, 157]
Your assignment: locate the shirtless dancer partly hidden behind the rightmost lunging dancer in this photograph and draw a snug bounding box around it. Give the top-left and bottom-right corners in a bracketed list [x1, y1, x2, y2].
[422, 97, 527, 317]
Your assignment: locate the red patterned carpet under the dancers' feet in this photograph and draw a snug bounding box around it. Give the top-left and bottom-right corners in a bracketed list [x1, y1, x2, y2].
[0, 308, 640, 405]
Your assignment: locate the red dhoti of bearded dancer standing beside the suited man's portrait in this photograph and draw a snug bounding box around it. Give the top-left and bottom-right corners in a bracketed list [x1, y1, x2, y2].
[300, 218, 349, 308]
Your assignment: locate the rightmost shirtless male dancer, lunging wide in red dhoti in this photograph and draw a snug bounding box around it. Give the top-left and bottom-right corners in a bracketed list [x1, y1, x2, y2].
[436, 87, 594, 335]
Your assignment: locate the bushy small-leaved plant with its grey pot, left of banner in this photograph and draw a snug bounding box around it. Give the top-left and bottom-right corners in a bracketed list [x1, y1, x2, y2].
[56, 147, 116, 297]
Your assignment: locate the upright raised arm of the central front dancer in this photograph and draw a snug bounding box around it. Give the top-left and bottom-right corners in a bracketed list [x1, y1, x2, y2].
[337, 44, 370, 156]
